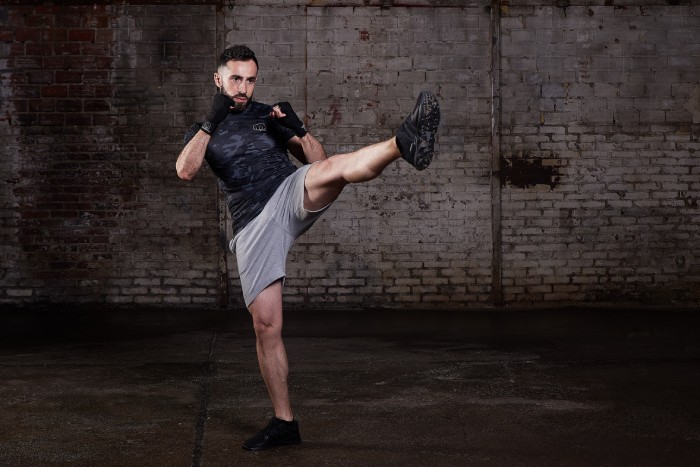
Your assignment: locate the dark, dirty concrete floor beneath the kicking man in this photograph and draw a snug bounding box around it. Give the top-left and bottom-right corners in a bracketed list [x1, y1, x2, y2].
[0, 308, 700, 466]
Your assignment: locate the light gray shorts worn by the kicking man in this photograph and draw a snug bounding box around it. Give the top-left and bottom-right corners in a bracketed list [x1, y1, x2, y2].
[229, 165, 330, 306]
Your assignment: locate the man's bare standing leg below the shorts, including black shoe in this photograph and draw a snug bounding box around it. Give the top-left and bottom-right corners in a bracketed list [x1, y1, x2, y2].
[243, 280, 301, 451]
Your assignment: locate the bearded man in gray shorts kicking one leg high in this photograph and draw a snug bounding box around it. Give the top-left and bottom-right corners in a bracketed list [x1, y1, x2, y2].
[176, 45, 440, 451]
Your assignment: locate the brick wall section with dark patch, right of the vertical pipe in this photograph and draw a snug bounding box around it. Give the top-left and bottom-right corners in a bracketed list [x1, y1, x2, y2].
[501, 2, 700, 304]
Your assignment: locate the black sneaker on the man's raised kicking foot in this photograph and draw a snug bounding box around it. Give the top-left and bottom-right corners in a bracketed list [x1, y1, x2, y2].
[396, 91, 440, 170]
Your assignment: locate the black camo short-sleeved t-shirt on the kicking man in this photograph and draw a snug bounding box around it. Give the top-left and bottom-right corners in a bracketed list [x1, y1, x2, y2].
[185, 102, 296, 235]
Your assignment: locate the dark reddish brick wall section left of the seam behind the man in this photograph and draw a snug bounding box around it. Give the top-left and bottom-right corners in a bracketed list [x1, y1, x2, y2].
[0, 5, 218, 304]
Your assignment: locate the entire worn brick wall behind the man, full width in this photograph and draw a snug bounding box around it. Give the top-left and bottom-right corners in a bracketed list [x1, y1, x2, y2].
[0, 0, 700, 308]
